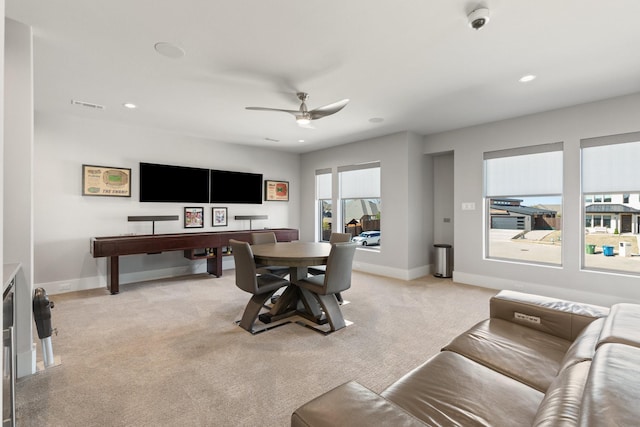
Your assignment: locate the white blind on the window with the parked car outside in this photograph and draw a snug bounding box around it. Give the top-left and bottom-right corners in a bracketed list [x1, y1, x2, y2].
[338, 162, 380, 199]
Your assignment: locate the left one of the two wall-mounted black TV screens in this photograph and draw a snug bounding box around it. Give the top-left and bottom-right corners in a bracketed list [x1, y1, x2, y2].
[140, 162, 209, 203]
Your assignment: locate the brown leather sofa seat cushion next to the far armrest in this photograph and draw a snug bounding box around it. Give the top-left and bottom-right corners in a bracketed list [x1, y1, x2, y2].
[443, 319, 571, 392]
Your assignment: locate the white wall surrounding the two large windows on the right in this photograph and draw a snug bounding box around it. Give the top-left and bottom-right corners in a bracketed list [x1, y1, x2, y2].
[425, 94, 640, 305]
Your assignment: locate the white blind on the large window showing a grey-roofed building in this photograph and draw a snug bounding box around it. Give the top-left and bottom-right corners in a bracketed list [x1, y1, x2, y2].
[484, 143, 562, 197]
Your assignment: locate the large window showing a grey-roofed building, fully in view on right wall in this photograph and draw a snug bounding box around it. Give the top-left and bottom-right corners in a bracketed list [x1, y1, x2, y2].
[484, 143, 562, 265]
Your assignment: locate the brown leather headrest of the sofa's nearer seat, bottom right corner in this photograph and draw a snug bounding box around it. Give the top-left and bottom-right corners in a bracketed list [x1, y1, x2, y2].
[579, 343, 640, 426]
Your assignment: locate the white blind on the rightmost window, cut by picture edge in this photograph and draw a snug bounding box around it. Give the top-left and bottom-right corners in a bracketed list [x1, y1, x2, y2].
[581, 134, 640, 193]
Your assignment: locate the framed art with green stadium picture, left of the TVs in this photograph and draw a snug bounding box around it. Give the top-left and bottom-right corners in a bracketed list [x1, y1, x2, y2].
[82, 165, 131, 197]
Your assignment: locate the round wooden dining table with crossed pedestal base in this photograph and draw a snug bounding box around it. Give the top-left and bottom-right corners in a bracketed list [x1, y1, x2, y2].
[251, 241, 331, 324]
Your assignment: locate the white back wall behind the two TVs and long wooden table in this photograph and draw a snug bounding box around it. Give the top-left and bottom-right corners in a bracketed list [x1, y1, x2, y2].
[34, 112, 300, 293]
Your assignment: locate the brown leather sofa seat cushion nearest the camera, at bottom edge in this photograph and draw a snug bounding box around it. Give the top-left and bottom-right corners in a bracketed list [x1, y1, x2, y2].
[382, 352, 543, 426]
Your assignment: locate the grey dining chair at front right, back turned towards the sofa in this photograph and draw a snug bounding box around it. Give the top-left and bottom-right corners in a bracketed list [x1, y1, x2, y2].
[296, 243, 356, 331]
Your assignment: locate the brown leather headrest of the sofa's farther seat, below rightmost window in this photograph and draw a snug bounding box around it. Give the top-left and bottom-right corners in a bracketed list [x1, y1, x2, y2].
[598, 303, 640, 347]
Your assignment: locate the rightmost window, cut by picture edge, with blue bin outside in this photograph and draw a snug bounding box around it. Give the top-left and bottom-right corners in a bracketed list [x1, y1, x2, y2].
[580, 132, 640, 274]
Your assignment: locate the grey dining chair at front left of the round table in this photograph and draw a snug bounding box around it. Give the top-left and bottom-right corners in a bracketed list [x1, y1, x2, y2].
[229, 239, 290, 333]
